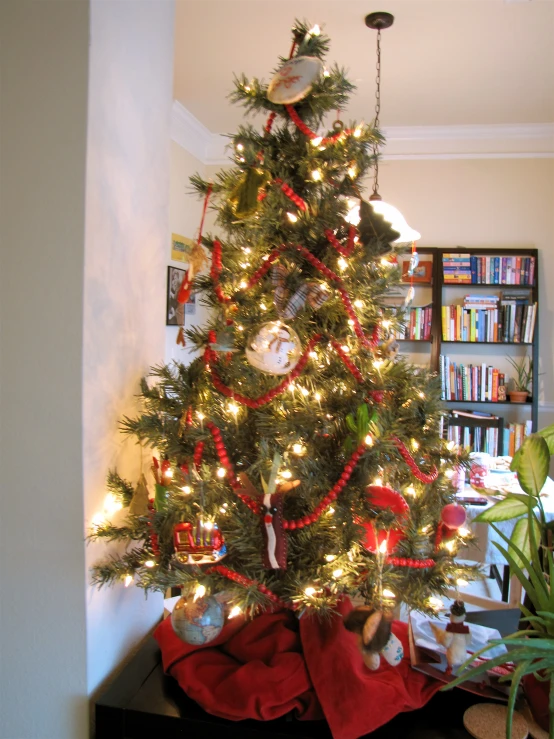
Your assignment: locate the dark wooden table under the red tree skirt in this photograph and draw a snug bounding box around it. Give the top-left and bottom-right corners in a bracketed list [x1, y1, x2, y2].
[95, 609, 520, 739]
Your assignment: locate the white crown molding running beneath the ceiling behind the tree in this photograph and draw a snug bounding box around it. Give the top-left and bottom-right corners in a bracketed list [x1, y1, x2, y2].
[171, 100, 554, 165]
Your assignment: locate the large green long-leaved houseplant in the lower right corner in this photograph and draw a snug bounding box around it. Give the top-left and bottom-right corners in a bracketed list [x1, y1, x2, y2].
[447, 425, 554, 739]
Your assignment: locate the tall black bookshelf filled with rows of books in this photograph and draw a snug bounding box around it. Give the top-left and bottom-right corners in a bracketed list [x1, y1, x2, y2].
[394, 247, 539, 454]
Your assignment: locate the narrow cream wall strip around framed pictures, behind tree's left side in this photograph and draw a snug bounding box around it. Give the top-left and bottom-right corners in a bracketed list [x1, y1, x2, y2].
[165, 141, 213, 364]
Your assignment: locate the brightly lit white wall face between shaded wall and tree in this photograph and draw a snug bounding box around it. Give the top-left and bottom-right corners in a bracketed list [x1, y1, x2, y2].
[83, 0, 174, 691]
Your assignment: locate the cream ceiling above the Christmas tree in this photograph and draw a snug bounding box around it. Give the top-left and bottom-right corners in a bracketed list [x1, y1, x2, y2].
[174, 0, 554, 133]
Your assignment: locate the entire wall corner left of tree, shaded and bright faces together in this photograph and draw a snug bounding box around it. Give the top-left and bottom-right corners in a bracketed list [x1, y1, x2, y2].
[0, 0, 174, 739]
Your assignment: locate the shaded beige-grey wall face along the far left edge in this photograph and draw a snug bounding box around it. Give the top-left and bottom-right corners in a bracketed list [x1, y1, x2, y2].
[0, 0, 89, 739]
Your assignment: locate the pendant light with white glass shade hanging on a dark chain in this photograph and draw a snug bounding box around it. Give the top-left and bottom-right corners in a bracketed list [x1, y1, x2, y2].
[358, 11, 421, 244]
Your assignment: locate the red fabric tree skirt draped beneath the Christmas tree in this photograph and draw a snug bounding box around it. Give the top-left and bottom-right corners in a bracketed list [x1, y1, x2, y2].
[154, 600, 440, 739]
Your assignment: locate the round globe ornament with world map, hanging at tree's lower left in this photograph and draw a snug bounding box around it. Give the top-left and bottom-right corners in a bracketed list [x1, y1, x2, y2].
[171, 595, 225, 646]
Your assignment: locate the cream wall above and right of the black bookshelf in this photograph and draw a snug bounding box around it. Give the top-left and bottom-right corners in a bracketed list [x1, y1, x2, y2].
[379, 159, 554, 414]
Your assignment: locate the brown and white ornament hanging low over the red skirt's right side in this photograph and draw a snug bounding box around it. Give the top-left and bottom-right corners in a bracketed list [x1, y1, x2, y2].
[344, 606, 404, 670]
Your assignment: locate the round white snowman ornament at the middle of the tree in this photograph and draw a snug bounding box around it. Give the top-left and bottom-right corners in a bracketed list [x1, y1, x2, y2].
[245, 321, 302, 375]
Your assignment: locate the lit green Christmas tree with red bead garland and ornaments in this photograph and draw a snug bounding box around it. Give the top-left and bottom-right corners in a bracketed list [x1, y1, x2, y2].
[91, 22, 472, 636]
